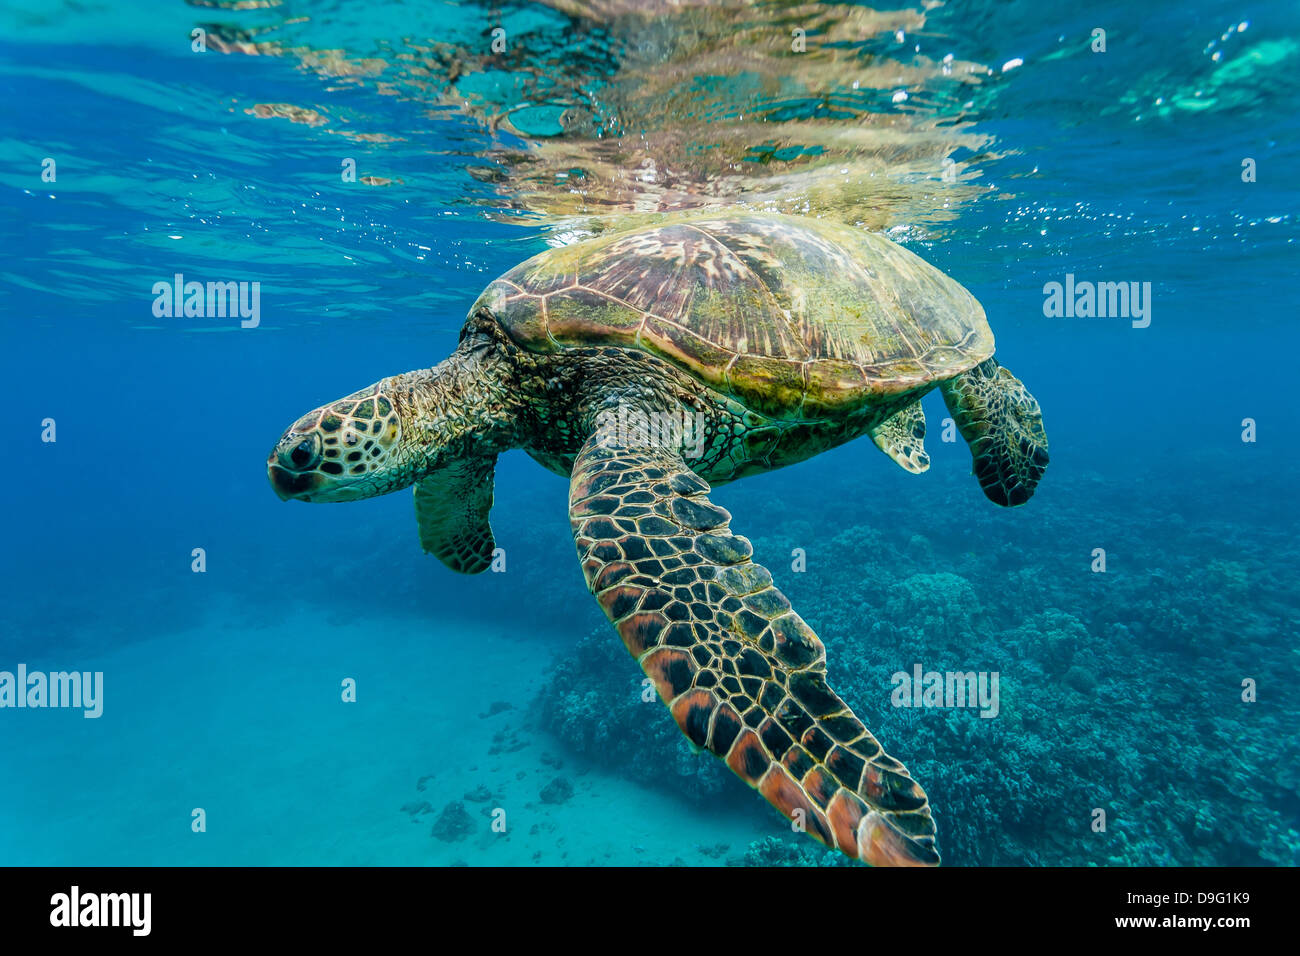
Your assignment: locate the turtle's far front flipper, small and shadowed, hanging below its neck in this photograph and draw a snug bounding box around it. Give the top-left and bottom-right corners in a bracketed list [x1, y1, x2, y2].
[415, 455, 497, 575]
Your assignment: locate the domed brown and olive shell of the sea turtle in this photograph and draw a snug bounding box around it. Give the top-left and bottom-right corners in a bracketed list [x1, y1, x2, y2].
[471, 213, 993, 419]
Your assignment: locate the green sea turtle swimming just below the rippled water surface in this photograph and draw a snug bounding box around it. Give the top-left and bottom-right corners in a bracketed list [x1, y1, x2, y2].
[268, 213, 1048, 865]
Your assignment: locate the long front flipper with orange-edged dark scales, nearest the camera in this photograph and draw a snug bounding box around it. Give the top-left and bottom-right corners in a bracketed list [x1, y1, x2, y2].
[569, 427, 939, 865]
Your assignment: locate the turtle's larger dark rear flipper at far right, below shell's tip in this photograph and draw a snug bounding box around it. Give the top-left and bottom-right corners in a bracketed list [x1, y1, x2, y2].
[940, 359, 1048, 507]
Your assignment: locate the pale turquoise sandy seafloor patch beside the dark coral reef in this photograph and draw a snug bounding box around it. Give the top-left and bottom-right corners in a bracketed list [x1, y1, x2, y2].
[0, 609, 781, 866]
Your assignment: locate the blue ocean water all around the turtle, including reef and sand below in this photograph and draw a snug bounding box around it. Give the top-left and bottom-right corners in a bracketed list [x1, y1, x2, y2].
[0, 0, 1300, 865]
